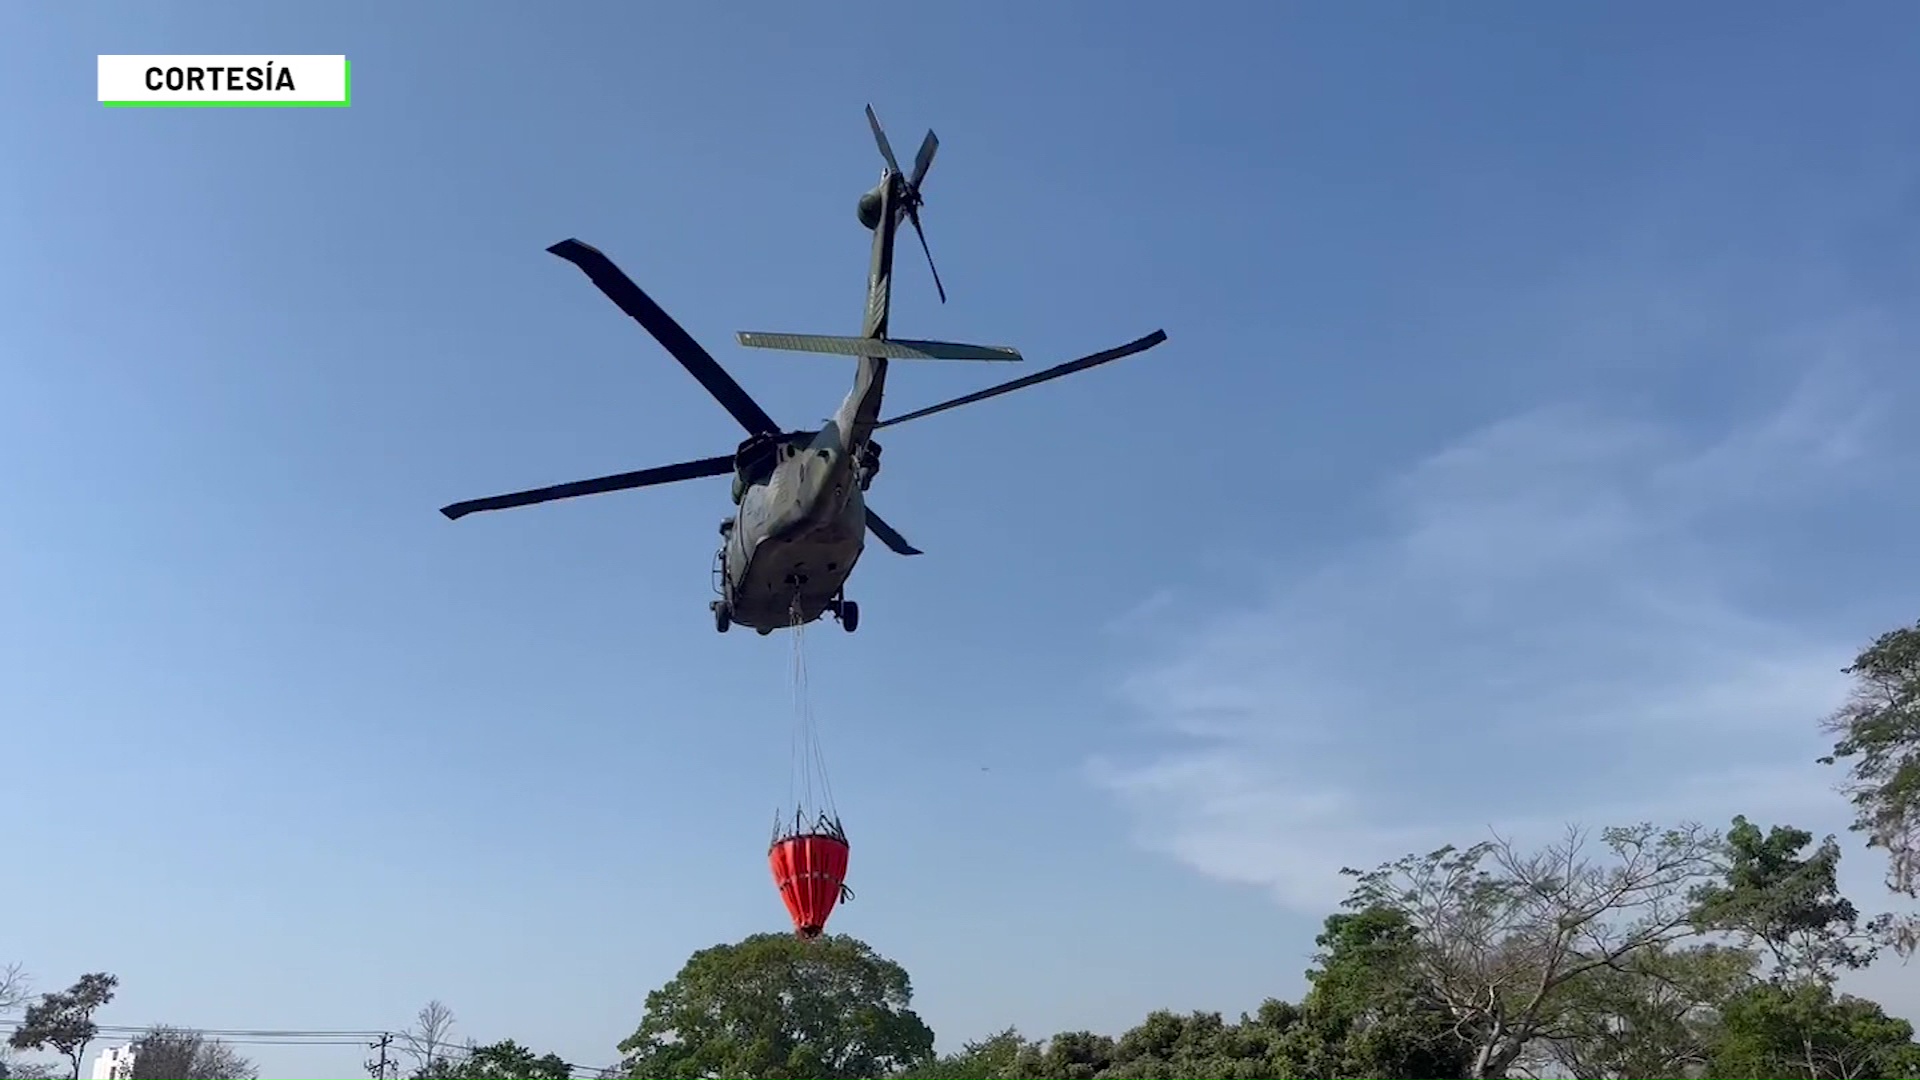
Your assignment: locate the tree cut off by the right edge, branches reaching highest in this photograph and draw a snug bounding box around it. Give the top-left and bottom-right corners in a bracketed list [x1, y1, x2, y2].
[1820, 623, 1920, 953]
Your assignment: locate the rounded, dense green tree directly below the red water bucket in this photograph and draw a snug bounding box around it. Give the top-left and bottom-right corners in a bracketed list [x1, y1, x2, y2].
[620, 934, 933, 1080]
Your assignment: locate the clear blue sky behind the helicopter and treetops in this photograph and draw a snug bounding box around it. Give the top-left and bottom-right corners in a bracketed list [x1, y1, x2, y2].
[0, 0, 1920, 1080]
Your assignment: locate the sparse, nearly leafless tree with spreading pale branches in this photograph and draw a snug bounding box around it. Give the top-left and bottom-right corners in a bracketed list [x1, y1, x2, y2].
[1344, 824, 1720, 1080]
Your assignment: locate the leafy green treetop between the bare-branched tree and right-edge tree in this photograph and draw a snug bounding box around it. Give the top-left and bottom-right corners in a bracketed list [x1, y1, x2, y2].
[1695, 817, 1887, 982]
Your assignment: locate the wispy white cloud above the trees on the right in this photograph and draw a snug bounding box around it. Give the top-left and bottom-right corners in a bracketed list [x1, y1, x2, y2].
[1091, 332, 1899, 913]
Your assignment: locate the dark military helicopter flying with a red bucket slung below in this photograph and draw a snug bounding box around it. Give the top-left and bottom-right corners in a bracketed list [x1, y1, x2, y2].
[440, 106, 1167, 634]
